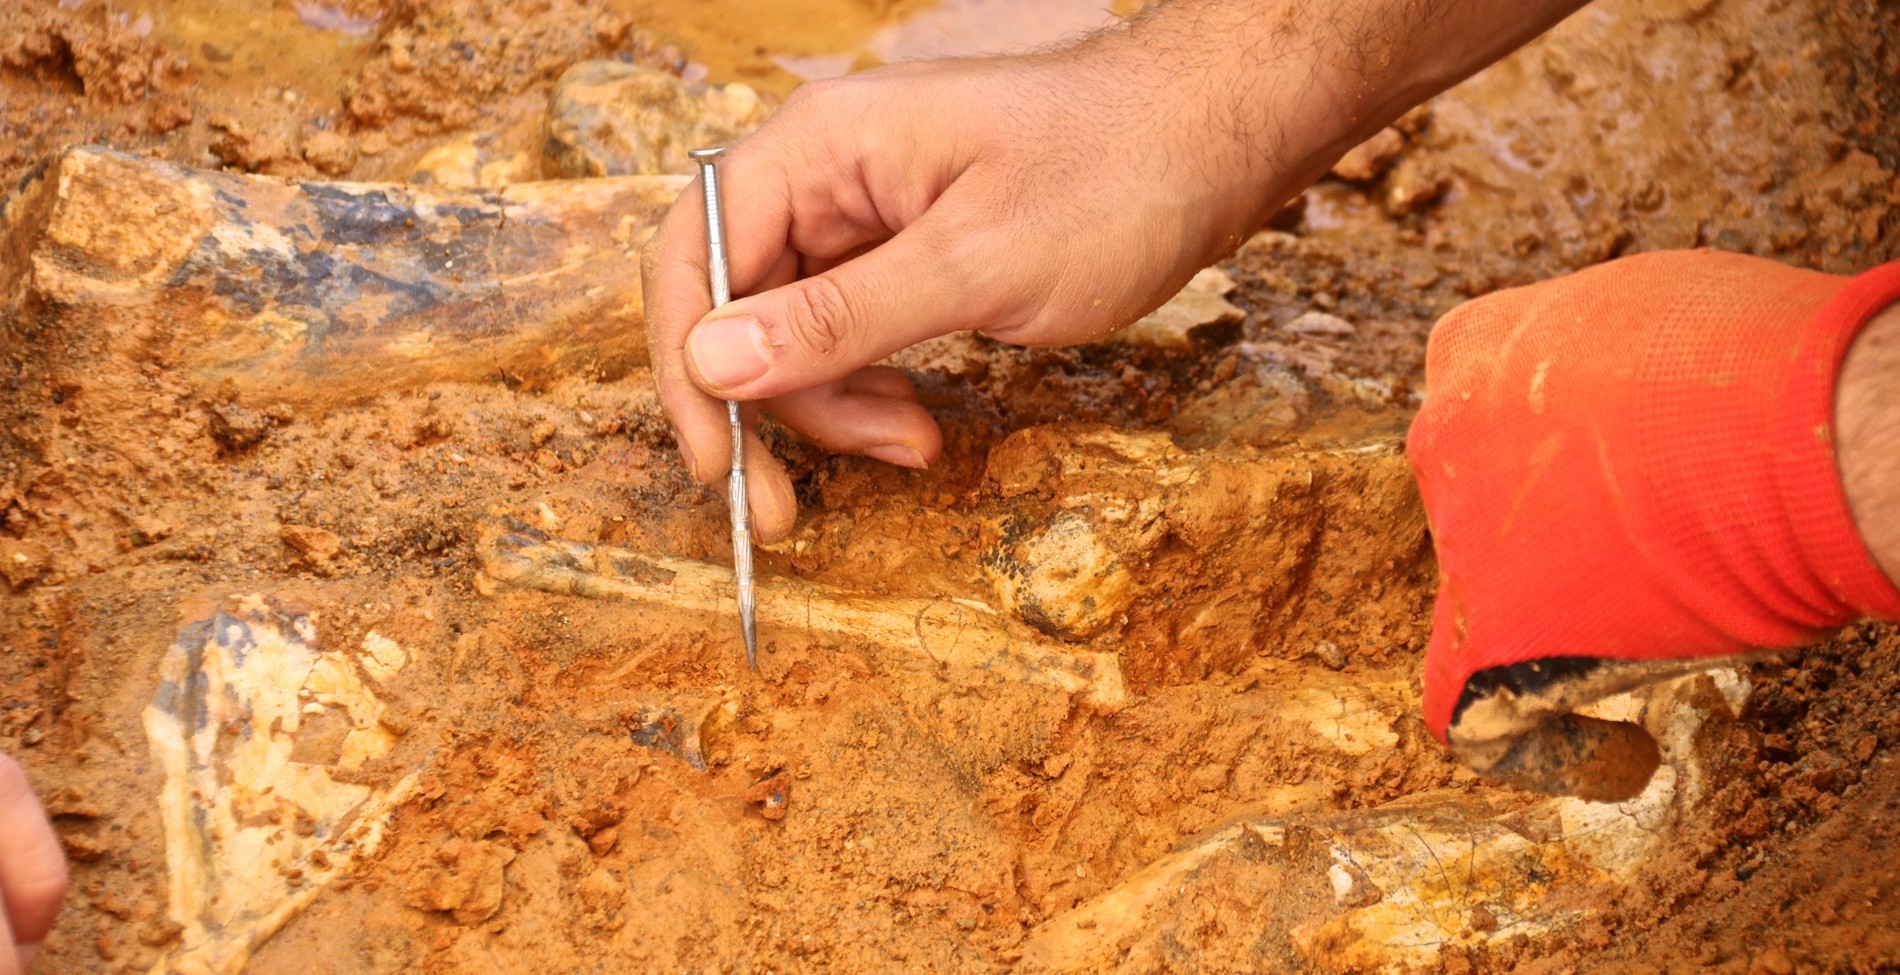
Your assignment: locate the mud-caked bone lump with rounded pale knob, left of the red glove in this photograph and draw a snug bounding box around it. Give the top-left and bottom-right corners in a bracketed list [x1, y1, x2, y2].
[982, 424, 1431, 682]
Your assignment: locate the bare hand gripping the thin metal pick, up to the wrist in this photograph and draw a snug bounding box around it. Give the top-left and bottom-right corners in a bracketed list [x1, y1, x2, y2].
[642, 30, 1351, 542]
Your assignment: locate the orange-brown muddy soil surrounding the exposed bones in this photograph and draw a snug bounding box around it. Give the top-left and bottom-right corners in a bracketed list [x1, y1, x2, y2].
[0, 0, 1900, 975]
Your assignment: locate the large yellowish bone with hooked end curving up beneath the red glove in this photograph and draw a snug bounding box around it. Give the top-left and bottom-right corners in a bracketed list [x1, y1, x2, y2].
[1022, 667, 1748, 975]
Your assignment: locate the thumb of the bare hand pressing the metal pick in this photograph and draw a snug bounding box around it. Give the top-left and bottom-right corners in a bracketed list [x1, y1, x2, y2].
[686, 211, 1009, 399]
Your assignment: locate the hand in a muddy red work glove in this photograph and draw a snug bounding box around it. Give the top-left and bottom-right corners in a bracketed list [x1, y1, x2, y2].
[1406, 251, 1900, 800]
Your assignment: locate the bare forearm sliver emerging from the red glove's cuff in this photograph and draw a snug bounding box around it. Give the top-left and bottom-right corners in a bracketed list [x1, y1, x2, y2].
[1834, 304, 1900, 583]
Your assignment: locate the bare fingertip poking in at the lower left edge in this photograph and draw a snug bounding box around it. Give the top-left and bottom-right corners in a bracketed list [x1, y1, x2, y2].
[0, 755, 67, 975]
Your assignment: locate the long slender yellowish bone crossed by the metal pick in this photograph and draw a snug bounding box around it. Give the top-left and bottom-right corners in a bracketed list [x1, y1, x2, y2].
[479, 526, 1129, 713]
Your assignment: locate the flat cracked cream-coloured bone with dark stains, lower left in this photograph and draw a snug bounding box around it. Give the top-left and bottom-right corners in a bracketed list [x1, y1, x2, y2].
[144, 597, 414, 975]
